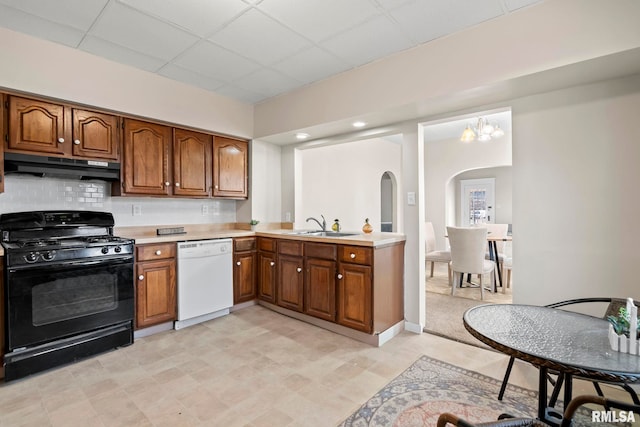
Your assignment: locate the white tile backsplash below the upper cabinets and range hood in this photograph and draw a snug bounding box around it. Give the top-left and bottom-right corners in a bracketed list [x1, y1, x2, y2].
[0, 175, 236, 227]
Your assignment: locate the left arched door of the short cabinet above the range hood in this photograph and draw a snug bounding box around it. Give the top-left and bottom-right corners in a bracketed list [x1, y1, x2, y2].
[7, 96, 66, 155]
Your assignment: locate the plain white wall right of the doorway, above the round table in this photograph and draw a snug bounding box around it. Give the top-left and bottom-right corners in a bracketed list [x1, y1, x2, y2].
[512, 75, 640, 304]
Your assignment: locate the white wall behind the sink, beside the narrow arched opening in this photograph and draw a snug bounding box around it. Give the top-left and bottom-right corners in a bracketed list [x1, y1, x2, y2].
[295, 138, 402, 231]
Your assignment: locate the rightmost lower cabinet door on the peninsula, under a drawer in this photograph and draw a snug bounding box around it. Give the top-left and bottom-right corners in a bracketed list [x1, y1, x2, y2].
[337, 264, 373, 334]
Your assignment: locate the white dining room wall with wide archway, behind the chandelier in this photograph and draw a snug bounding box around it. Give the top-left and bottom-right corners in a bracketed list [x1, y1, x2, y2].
[424, 133, 512, 249]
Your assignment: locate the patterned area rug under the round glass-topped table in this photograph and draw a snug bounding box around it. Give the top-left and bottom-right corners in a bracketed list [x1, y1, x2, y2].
[340, 356, 593, 427]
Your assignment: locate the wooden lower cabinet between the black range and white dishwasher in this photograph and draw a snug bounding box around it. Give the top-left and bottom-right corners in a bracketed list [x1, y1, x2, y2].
[135, 243, 177, 329]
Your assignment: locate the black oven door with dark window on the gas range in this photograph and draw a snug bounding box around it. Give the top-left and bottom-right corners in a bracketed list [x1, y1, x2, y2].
[7, 260, 134, 351]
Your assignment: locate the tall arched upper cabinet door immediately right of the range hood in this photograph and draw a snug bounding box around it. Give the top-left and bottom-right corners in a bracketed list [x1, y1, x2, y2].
[122, 119, 173, 195]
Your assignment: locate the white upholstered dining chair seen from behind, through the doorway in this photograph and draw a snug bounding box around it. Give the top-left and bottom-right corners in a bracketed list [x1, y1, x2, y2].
[447, 227, 496, 299]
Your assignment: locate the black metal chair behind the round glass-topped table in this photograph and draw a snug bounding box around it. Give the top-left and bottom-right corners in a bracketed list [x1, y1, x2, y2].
[498, 297, 640, 405]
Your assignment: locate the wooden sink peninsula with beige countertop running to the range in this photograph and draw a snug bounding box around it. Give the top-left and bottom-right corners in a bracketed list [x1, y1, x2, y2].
[116, 225, 405, 346]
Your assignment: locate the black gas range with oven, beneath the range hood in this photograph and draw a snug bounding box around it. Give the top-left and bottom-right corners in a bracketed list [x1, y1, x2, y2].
[0, 211, 134, 381]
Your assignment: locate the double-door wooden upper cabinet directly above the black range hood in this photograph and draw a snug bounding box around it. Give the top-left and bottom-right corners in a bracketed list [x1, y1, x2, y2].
[6, 96, 120, 161]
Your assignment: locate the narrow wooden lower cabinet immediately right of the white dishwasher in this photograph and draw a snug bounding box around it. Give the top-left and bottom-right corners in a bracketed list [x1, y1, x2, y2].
[233, 237, 257, 304]
